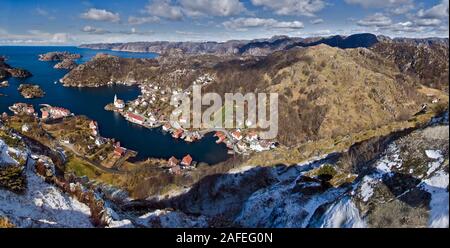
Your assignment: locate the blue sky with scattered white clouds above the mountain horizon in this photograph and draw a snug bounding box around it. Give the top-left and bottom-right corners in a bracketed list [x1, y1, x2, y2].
[0, 0, 449, 45]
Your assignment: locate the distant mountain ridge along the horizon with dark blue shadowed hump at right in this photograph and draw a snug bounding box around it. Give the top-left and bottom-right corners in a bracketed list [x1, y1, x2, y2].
[80, 33, 449, 56]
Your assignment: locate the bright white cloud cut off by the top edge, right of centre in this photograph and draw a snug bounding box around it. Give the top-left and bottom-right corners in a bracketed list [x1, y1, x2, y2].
[251, 0, 326, 16]
